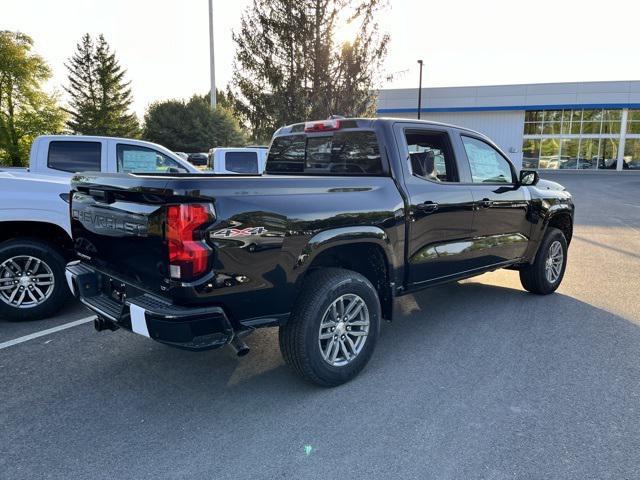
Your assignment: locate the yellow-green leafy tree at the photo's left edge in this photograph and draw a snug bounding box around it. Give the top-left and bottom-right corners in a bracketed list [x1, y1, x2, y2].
[0, 30, 64, 167]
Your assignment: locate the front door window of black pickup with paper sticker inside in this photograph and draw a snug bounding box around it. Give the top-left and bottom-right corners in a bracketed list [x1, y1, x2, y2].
[462, 136, 514, 187]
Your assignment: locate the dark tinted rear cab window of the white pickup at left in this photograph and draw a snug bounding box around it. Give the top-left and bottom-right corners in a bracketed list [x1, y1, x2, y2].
[47, 141, 102, 173]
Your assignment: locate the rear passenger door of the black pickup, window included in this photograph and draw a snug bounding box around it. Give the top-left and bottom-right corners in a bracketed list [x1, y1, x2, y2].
[394, 123, 473, 286]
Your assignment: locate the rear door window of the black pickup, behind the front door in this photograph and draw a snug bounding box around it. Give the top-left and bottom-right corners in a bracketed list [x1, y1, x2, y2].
[405, 131, 457, 182]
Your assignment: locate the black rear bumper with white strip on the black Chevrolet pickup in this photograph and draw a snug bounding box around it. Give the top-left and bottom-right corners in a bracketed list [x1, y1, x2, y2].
[65, 263, 234, 350]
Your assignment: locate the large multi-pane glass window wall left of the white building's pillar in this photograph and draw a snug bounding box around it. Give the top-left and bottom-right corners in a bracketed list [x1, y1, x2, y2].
[522, 109, 624, 170]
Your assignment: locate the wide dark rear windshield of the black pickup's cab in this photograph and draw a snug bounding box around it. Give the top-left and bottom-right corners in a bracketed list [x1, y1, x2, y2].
[266, 131, 385, 175]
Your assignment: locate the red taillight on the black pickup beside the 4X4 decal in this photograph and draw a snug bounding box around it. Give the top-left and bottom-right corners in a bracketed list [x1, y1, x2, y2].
[167, 203, 212, 280]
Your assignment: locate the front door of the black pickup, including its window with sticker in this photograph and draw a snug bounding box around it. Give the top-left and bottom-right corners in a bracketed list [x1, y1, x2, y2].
[459, 132, 531, 267]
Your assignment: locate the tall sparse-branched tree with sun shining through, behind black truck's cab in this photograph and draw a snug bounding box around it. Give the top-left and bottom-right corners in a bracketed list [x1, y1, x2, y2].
[232, 0, 389, 138]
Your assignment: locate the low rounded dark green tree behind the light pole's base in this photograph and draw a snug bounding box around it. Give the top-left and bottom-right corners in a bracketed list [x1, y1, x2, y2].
[143, 94, 246, 152]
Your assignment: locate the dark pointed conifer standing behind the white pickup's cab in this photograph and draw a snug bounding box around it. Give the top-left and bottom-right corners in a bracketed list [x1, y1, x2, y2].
[65, 33, 139, 137]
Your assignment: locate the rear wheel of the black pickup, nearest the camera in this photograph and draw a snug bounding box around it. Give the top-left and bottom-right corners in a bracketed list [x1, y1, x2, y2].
[279, 268, 381, 387]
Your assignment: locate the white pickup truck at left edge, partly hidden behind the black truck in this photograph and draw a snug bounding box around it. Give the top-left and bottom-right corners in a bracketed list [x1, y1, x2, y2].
[0, 135, 199, 320]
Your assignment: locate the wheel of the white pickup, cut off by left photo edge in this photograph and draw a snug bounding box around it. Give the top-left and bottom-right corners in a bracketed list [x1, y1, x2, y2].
[0, 238, 71, 321]
